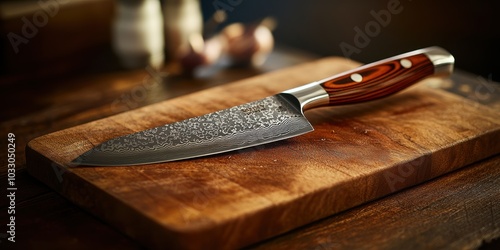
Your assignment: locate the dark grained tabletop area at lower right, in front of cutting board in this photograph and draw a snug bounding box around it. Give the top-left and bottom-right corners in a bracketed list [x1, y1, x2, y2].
[248, 155, 500, 250]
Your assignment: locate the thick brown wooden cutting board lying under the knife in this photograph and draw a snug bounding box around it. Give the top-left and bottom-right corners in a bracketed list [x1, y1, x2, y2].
[26, 58, 500, 249]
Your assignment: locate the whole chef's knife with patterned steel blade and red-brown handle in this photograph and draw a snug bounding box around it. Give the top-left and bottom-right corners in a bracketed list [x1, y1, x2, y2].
[72, 47, 454, 166]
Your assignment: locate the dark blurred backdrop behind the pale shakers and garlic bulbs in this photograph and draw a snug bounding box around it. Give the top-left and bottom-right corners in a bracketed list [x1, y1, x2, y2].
[0, 0, 500, 82]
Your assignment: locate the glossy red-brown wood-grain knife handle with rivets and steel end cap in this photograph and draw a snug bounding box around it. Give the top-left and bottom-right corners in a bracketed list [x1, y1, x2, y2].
[319, 47, 454, 105]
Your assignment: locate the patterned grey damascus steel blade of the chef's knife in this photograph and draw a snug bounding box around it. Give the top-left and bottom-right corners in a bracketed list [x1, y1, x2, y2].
[72, 93, 314, 166]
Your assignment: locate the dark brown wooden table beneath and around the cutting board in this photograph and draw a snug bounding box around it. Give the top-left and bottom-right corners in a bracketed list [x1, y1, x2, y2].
[0, 46, 500, 249]
